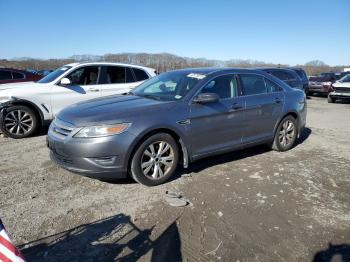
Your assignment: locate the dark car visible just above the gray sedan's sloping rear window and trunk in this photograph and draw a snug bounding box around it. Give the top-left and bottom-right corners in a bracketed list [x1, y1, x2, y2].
[259, 68, 304, 90]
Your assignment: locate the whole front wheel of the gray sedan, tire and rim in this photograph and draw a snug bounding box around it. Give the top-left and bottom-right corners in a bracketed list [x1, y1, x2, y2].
[129, 133, 179, 186]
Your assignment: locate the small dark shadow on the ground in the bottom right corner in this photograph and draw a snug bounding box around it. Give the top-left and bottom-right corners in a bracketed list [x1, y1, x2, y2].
[312, 243, 350, 262]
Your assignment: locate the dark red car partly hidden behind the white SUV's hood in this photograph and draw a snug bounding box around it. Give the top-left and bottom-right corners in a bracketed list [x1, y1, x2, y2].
[0, 68, 42, 84]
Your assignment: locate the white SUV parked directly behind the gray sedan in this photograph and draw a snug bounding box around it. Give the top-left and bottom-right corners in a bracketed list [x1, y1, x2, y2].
[0, 62, 156, 138]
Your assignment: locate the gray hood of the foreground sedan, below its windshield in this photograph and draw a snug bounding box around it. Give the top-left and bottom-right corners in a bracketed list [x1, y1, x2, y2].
[57, 95, 176, 127]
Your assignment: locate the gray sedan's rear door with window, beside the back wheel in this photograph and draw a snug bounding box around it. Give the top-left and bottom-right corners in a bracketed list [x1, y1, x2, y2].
[239, 74, 284, 144]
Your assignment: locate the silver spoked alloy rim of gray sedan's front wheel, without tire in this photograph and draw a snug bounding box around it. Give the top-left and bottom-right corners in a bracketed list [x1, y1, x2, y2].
[141, 141, 174, 179]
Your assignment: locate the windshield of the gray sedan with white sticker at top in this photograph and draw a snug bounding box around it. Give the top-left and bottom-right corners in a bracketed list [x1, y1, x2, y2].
[131, 71, 206, 101]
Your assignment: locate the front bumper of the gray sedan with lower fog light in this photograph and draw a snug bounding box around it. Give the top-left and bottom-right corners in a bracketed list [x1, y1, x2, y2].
[47, 130, 135, 179]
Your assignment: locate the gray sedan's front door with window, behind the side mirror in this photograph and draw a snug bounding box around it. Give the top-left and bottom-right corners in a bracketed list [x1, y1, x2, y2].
[190, 74, 244, 157]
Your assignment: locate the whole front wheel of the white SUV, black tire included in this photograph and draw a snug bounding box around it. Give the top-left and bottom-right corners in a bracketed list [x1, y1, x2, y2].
[0, 106, 39, 139]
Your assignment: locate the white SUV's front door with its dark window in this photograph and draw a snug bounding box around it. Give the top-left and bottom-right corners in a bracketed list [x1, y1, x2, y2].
[51, 66, 101, 116]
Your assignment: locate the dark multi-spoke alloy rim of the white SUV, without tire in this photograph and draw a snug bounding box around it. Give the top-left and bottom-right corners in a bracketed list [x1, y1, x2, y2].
[4, 110, 33, 135]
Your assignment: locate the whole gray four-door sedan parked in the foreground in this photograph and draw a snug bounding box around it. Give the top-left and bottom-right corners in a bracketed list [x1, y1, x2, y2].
[47, 68, 306, 186]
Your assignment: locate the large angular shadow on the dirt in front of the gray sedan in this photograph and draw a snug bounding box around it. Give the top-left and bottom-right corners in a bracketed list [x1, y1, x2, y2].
[20, 214, 182, 262]
